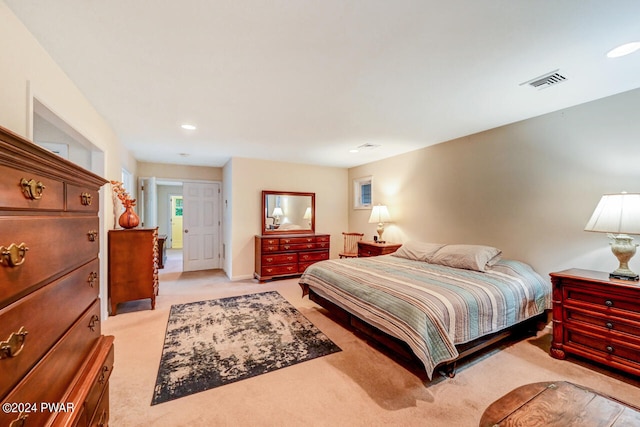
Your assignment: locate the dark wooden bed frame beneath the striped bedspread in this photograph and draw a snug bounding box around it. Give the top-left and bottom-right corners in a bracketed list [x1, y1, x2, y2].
[300, 284, 550, 378]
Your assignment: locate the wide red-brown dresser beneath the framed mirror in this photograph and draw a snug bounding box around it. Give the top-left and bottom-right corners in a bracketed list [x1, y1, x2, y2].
[253, 234, 331, 282]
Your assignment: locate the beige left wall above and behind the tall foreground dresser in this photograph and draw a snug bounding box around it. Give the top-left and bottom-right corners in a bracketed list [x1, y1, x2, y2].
[0, 2, 136, 315]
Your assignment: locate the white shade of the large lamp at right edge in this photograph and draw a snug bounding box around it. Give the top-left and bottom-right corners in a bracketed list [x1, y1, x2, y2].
[584, 193, 640, 234]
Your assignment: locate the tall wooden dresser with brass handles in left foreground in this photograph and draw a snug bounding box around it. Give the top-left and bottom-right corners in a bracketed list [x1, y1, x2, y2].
[0, 128, 114, 427]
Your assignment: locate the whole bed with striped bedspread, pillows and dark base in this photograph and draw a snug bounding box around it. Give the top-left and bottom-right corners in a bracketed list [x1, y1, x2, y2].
[299, 242, 551, 379]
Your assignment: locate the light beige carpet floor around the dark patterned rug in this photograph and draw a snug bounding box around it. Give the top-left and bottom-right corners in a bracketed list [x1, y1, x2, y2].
[102, 253, 640, 427]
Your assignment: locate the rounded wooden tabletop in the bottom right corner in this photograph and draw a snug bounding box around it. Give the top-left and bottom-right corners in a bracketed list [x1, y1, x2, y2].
[480, 381, 640, 427]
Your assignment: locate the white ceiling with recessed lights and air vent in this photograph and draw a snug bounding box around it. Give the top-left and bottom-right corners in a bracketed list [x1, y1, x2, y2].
[5, 0, 640, 167]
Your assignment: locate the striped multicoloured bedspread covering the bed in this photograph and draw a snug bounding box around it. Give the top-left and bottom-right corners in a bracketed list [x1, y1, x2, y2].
[299, 255, 551, 378]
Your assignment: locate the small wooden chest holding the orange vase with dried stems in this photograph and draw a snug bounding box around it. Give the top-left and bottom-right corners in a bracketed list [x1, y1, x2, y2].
[109, 228, 159, 316]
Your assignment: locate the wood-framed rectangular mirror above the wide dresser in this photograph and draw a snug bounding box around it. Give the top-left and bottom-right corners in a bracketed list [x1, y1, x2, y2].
[262, 190, 316, 234]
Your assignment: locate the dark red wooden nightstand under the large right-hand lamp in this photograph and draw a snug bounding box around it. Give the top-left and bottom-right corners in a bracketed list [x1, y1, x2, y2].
[550, 269, 640, 375]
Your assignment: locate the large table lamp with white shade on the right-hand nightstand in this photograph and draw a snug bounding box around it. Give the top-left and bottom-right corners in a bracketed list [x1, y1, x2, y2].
[584, 193, 640, 280]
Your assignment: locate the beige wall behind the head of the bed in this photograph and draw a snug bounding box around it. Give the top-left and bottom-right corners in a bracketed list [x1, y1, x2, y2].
[349, 89, 640, 275]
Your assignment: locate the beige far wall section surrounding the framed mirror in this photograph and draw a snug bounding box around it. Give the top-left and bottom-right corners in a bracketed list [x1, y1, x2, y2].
[222, 158, 347, 279]
